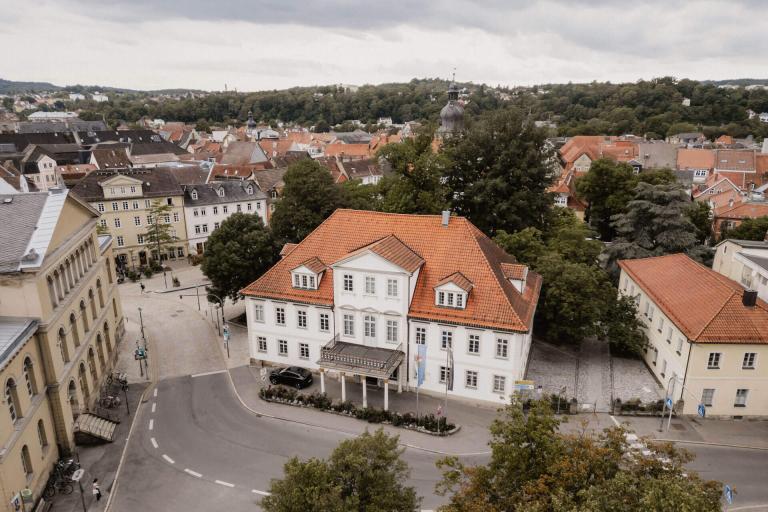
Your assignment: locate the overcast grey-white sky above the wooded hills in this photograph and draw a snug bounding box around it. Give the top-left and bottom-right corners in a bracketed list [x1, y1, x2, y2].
[0, 0, 768, 91]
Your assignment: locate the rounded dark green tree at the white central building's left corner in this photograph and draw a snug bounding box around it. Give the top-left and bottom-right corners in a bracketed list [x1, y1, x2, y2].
[201, 213, 278, 300]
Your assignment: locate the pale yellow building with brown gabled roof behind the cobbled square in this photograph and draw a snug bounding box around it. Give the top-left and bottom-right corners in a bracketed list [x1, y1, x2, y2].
[72, 167, 187, 269]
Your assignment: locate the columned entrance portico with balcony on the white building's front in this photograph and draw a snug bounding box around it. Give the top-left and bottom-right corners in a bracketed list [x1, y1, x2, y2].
[317, 336, 405, 410]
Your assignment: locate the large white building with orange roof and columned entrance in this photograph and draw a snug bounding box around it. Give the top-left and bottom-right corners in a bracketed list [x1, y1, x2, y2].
[242, 210, 541, 406]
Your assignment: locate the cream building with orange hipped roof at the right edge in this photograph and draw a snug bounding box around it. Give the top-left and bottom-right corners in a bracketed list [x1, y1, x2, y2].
[619, 254, 768, 418]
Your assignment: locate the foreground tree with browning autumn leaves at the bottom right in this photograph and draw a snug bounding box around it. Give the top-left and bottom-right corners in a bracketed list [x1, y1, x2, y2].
[437, 400, 721, 512]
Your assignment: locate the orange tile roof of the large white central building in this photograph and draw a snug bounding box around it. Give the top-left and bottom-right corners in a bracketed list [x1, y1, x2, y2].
[242, 209, 541, 332]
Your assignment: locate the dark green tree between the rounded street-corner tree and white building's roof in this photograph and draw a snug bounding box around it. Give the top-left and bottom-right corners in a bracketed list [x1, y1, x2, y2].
[270, 160, 343, 243]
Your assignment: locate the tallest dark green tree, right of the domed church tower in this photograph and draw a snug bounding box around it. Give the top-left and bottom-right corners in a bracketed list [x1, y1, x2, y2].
[443, 109, 552, 236]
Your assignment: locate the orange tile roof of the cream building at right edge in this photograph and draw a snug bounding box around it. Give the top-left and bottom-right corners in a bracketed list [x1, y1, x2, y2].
[619, 254, 768, 343]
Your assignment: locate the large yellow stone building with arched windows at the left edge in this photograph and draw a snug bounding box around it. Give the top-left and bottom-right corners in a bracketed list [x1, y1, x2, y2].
[0, 189, 123, 510]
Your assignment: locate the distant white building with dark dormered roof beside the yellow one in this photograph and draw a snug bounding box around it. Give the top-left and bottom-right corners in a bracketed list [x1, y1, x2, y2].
[182, 180, 268, 255]
